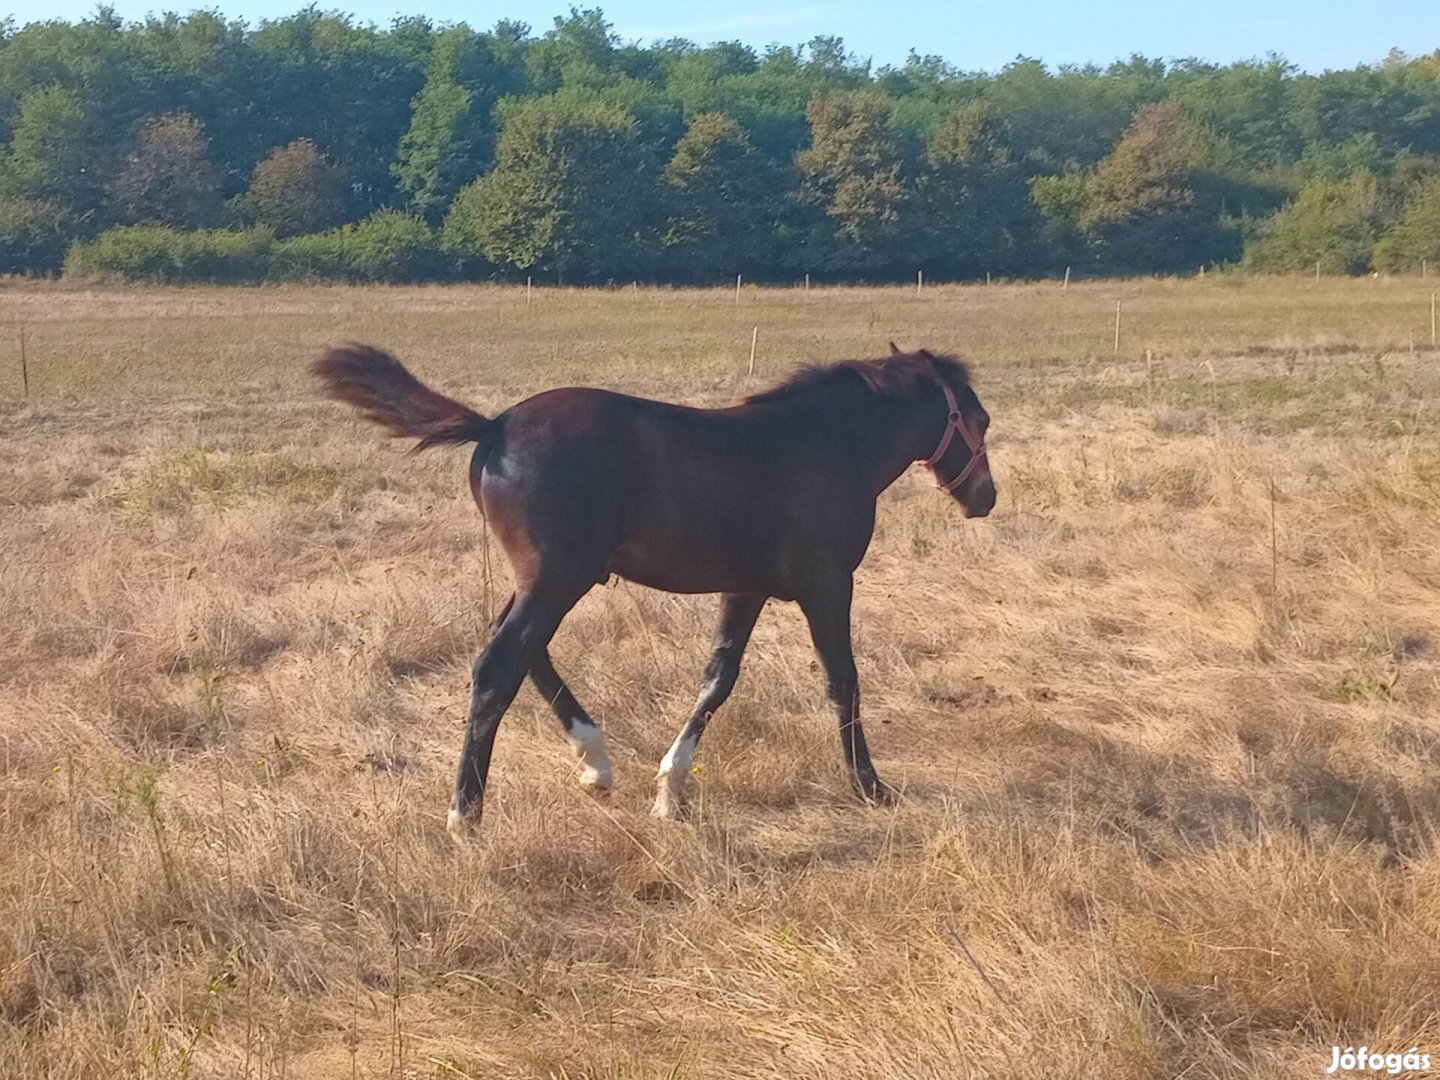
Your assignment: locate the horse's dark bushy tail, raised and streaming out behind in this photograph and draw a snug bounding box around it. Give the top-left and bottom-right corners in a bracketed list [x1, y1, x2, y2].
[310, 344, 497, 451]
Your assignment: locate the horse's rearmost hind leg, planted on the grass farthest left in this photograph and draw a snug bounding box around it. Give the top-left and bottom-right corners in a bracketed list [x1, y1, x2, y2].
[446, 588, 585, 840]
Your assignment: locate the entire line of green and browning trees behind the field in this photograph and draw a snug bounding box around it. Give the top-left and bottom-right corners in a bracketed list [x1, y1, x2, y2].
[0, 7, 1440, 284]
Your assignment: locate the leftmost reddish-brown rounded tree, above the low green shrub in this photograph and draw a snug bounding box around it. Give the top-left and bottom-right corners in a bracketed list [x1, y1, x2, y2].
[108, 112, 222, 229]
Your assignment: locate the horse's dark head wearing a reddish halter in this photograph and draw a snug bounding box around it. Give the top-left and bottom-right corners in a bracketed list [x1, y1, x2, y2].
[890, 343, 995, 517]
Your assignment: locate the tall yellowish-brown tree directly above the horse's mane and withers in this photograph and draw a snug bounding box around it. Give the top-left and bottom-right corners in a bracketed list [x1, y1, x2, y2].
[795, 91, 907, 271]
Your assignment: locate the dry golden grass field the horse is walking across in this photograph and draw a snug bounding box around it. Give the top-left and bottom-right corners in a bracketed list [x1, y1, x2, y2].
[0, 278, 1440, 1080]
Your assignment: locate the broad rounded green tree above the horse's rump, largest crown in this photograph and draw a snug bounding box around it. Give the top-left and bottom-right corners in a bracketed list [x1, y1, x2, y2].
[445, 96, 654, 281]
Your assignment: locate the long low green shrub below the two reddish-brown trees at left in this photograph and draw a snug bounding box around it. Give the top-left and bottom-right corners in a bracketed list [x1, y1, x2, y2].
[65, 225, 275, 284]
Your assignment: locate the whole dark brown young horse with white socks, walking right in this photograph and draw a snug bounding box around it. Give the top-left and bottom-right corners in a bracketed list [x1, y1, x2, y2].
[314, 346, 995, 840]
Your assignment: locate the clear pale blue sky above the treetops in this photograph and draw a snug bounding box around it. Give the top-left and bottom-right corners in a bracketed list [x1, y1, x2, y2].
[14, 0, 1440, 71]
